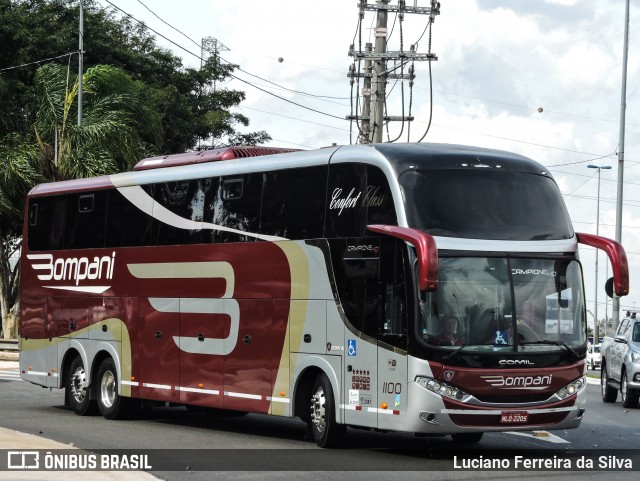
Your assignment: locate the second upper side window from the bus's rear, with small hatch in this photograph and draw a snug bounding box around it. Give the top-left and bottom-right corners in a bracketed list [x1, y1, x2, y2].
[65, 190, 108, 249]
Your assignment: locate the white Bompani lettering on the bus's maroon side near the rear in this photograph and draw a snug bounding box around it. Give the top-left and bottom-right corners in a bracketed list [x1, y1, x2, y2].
[27, 252, 116, 286]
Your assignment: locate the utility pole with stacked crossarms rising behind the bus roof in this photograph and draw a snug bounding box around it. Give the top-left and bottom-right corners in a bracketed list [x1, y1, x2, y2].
[347, 0, 440, 143]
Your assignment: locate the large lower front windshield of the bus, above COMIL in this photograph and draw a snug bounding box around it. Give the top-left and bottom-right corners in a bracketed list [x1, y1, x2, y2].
[417, 257, 586, 351]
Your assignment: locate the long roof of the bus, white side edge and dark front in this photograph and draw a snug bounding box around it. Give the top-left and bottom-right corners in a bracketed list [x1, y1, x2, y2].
[29, 143, 551, 197]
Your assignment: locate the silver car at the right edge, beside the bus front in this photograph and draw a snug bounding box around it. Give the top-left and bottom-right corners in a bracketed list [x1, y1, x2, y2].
[600, 313, 640, 408]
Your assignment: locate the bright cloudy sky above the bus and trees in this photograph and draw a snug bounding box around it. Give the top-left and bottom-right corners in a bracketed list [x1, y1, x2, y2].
[96, 0, 640, 324]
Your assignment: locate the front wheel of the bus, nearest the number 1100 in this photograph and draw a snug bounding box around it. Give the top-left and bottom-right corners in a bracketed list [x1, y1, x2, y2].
[309, 373, 347, 448]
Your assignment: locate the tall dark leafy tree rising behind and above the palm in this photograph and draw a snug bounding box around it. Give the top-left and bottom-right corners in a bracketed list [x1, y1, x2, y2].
[0, 0, 271, 154]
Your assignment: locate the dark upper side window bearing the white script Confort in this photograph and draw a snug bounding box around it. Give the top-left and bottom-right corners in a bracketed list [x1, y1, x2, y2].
[326, 164, 397, 237]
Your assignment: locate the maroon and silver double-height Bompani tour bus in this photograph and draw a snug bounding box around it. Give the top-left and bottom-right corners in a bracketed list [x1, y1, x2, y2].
[20, 144, 628, 447]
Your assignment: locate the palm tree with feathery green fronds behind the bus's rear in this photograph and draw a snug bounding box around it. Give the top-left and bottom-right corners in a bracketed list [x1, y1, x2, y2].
[0, 64, 161, 337]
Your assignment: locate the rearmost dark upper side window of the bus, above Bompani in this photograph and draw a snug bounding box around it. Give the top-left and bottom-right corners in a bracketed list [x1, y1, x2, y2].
[29, 195, 67, 251]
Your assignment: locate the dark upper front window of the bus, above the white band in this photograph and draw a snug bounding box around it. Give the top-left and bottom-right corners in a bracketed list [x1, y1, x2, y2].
[400, 169, 573, 240]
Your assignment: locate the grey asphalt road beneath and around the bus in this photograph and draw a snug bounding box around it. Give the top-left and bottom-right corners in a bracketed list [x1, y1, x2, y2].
[0, 366, 640, 481]
